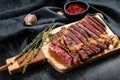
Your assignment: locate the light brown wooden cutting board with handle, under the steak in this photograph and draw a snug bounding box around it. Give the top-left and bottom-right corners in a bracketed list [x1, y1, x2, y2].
[0, 14, 120, 74]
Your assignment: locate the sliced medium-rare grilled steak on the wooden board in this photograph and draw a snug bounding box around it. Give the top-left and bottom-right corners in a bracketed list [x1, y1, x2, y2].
[50, 15, 110, 65]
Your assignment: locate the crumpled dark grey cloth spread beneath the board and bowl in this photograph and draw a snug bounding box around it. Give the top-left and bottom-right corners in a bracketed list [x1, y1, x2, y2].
[0, 0, 120, 80]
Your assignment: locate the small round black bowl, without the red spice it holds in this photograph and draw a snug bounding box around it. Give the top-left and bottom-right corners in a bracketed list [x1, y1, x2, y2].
[64, 1, 89, 18]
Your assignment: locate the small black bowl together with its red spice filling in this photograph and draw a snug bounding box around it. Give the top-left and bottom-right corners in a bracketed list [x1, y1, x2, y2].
[64, 1, 89, 18]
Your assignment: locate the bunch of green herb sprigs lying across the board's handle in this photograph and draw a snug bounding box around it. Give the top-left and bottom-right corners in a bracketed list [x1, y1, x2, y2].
[15, 21, 55, 73]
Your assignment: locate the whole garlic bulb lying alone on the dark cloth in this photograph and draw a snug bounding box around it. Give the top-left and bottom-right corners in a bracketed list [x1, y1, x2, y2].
[24, 14, 37, 25]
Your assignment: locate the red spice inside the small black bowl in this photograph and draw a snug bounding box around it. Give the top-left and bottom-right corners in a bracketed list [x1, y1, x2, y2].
[66, 3, 85, 14]
